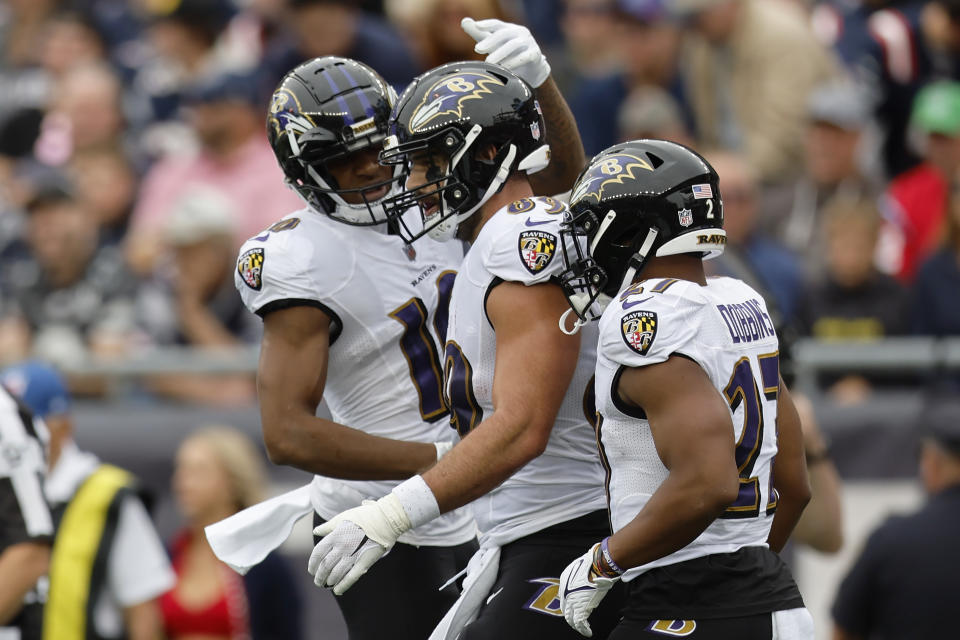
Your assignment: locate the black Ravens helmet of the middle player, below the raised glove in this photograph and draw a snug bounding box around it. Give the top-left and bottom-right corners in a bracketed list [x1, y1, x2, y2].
[380, 62, 550, 242]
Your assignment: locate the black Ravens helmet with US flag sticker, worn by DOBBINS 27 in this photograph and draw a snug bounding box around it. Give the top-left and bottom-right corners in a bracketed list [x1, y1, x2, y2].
[560, 140, 727, 323]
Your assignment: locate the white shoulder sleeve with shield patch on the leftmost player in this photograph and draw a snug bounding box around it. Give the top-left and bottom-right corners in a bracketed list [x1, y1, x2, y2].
[234, 210, 357, 332]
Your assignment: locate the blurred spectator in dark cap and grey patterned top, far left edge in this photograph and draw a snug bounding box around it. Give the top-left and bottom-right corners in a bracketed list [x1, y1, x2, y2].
[0, 178, 135, 364]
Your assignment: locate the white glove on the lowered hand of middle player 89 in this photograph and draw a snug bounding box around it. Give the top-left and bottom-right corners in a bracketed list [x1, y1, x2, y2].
[307, 493, 411, 596]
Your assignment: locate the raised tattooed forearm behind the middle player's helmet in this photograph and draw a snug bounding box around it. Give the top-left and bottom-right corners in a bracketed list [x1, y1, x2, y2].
[530, 77, 587, 196]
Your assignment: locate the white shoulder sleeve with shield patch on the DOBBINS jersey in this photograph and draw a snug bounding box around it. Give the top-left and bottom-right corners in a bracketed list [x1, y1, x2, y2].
[600, 279, 697, 367]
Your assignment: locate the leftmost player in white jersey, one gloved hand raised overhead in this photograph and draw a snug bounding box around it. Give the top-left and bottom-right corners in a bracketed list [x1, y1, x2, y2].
[219, 20, 583, 640]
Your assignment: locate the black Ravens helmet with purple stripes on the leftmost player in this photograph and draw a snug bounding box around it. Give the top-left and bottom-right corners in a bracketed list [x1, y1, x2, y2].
[267, 56, 400, 225]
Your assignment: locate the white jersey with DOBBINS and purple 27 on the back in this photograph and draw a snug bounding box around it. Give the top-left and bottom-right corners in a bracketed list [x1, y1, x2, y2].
[596, 278, 780, 580]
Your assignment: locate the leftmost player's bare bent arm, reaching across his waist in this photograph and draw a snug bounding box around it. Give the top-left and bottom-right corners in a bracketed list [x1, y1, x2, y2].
[257, 306, 437, 480]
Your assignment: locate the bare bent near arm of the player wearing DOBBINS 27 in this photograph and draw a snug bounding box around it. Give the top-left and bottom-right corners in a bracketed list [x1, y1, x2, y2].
[608, 356, 740, 568]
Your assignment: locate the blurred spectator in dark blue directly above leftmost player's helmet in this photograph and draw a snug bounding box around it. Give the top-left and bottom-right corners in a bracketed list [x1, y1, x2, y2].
[265, 0, 416, 91]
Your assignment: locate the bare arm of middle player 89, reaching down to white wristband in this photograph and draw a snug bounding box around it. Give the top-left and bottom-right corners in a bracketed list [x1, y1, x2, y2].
[423, 282, 580, 513]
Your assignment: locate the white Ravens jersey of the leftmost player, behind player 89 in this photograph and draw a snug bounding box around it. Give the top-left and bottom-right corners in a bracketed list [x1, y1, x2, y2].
[234, 208, 476, 546]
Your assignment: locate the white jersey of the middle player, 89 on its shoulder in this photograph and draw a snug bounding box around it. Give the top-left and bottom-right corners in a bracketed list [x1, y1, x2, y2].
[444, 198, 606, 544]
